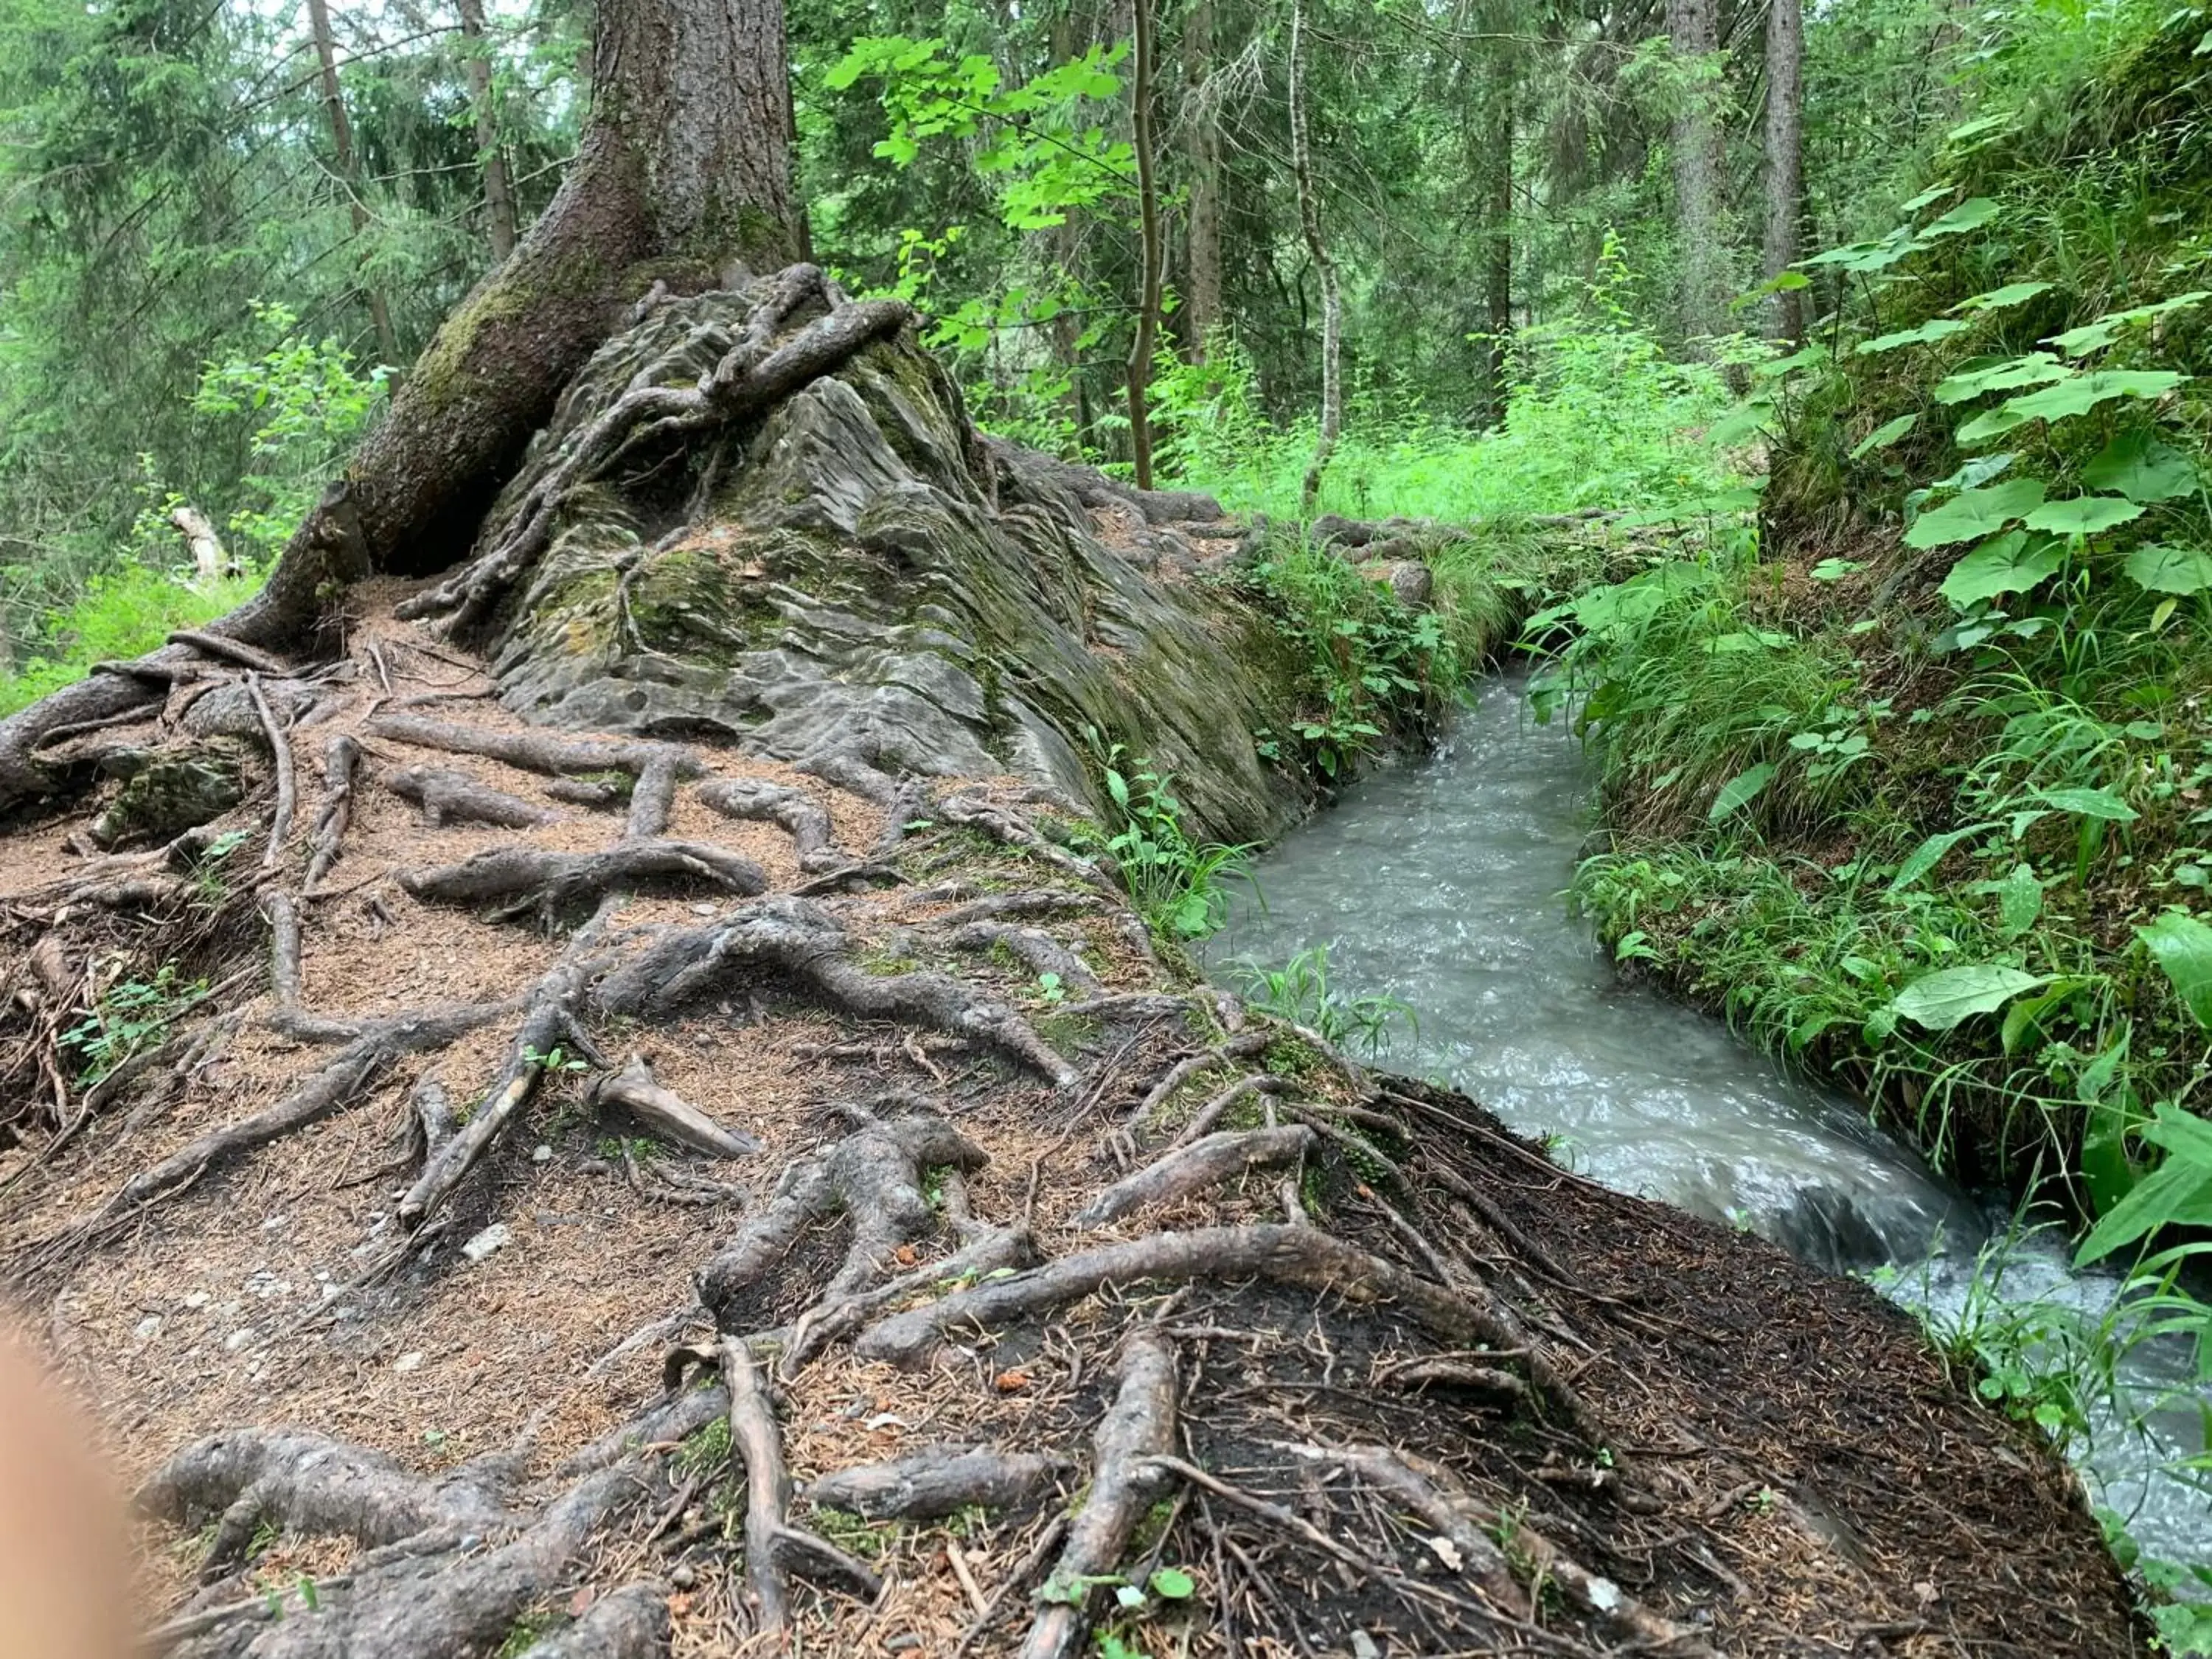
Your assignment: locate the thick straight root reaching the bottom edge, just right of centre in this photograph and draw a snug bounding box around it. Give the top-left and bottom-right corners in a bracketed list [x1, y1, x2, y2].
[1022, 1327, 1177, 1659]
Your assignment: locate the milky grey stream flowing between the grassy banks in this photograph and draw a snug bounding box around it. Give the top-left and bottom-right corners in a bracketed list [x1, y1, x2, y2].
[1208, 677, 2212, 1564]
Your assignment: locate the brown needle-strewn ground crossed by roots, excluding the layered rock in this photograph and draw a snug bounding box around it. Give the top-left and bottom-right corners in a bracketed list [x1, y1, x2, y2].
[0, 571, 2139, 1659]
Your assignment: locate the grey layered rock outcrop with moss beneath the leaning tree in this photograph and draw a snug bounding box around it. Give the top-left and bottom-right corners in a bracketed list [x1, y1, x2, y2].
[469, 283, 1296, 841]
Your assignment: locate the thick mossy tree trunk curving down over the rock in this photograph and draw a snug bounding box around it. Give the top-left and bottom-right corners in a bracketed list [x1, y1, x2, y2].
[0, 0, 803, 810]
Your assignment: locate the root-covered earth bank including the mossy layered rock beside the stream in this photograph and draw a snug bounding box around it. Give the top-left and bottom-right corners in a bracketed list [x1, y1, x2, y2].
[0, 272, 2137, 1659]
